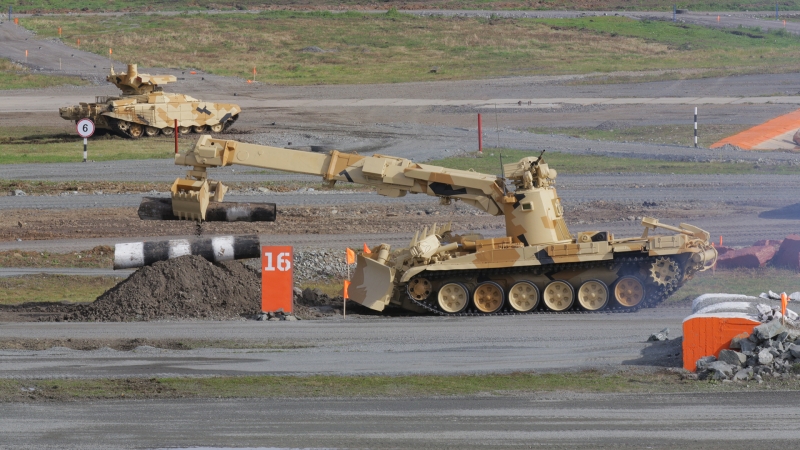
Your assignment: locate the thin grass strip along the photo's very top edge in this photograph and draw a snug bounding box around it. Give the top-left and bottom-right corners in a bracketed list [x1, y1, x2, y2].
[7, 0, 800, 12]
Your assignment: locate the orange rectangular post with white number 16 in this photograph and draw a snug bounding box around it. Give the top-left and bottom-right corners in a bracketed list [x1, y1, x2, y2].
[261, 246, 294, 314]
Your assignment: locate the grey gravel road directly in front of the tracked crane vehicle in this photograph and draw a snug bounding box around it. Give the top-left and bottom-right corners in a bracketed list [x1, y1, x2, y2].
[0, 308, 690, 378]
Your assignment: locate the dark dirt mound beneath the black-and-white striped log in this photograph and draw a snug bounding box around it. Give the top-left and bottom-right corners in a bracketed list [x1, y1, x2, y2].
[62, 256, 261, 322]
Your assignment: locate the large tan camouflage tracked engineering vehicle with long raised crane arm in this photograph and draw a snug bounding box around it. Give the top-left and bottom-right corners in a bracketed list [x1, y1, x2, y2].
[153, 135, 717, 314]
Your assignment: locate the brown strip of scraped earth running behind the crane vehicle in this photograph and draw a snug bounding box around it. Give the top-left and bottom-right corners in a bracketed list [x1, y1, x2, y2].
[0, 198, 736, 241]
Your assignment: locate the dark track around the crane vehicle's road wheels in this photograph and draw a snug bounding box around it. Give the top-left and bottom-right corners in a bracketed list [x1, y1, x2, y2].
[406, 256, 684, 317]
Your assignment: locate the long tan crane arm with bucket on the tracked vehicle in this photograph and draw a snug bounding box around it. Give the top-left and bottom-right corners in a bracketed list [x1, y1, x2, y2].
[172, 135, 504, 220]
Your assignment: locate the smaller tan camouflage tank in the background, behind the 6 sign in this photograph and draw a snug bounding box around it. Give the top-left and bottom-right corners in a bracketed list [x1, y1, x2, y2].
[58, 64, 241, 139]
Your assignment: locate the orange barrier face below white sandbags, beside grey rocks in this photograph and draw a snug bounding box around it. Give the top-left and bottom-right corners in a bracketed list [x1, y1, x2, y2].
[683, 314, 761, 372]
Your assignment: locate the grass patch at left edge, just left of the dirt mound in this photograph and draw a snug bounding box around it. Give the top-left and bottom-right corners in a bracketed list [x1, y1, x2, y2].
[0, 274, 120, 305]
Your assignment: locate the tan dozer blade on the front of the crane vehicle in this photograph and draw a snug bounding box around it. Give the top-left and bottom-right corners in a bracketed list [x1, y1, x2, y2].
[348, 255, 394, 311]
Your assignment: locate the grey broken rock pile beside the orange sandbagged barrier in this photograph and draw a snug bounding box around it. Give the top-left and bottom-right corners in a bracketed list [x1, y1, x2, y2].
[697, 304, 800, 383]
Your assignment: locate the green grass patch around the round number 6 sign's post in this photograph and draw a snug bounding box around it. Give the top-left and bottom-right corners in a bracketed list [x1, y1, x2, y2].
[0, 126, 184, 164]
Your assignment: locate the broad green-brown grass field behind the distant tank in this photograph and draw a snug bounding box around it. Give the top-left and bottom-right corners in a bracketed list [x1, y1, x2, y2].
[21, 11, 800, 85]
